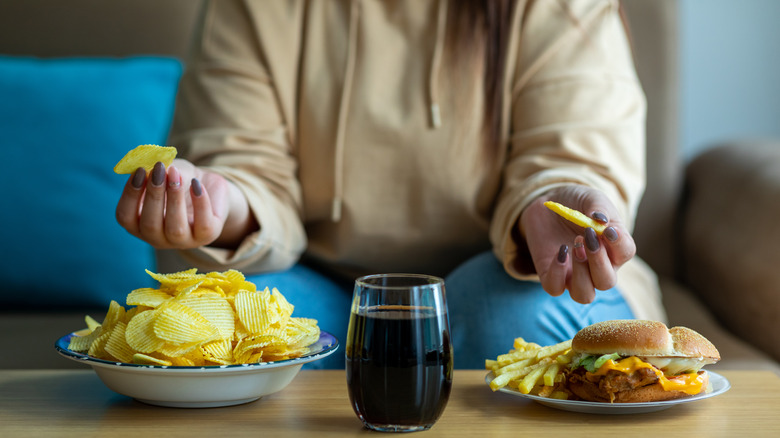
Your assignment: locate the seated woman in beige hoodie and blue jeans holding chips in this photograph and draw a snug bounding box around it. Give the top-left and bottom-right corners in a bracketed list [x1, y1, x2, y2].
[117, 0, 664, 368]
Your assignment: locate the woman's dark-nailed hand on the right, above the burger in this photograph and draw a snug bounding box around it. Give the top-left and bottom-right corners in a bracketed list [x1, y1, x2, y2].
[518, 185, 636, 304]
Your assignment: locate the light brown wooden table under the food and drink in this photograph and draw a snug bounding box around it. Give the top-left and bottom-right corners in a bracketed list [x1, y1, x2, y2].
[0, 370, 780, 438]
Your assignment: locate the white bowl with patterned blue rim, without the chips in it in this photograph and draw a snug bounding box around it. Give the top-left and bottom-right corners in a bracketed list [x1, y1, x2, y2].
[54, 331, 339, 408]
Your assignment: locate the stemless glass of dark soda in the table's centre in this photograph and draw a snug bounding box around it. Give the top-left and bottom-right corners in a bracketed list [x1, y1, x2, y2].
[346, 274, 453, 432]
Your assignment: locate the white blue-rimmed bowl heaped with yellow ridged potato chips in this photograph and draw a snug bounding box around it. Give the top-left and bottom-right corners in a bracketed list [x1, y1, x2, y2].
[55, 269, 338, 408]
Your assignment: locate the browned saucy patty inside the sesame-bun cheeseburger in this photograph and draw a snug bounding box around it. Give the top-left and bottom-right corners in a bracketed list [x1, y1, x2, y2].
[567, 368, 658, 402]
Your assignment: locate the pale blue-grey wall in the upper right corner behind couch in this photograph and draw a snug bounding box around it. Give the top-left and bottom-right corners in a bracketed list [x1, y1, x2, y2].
[679, 0, 780, 160]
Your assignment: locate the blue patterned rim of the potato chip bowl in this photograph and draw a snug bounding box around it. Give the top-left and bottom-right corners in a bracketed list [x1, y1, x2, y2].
[54, 331, 339, 371]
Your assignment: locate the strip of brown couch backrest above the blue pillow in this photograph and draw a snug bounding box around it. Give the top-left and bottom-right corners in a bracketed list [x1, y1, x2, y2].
[0, 0, 201, 59]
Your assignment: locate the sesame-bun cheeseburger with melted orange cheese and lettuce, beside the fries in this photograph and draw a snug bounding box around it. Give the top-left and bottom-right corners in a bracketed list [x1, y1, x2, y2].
[566, 320, 720, 403]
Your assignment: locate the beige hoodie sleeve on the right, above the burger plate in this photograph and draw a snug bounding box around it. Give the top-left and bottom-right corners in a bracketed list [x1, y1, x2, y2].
[490, 0, 646, 279]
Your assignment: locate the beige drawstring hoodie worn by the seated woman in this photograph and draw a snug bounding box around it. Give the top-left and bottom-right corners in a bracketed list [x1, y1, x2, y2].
[162, 0, 665, 320]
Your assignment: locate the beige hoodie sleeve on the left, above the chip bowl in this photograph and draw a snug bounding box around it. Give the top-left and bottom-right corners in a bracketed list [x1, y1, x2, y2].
[171, 0, 306, 273]
